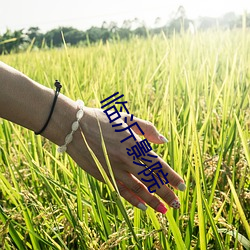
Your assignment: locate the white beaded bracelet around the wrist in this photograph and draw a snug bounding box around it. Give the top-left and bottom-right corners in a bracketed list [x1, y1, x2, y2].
[57, 100, 84, 153]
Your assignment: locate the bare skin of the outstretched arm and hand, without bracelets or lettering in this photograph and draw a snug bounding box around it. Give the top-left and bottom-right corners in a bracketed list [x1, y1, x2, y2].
[0, 62, 184, 213]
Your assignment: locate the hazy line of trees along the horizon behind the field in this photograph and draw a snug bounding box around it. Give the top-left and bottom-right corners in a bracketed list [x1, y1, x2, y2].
[0, 10, 250, 54]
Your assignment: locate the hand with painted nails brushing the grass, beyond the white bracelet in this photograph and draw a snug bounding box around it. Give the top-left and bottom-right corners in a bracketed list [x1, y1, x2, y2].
[67, 107, 186, 213]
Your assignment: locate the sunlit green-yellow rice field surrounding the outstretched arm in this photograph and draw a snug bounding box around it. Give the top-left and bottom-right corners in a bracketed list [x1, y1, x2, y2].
[0, 29, 250, 250]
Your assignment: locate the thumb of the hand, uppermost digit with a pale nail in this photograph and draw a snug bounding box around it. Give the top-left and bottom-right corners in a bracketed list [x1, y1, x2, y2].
[124, 116, 168, 144]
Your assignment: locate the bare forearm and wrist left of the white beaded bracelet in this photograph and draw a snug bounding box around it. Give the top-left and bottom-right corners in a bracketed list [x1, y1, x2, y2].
[0, 62, 76, 145]
